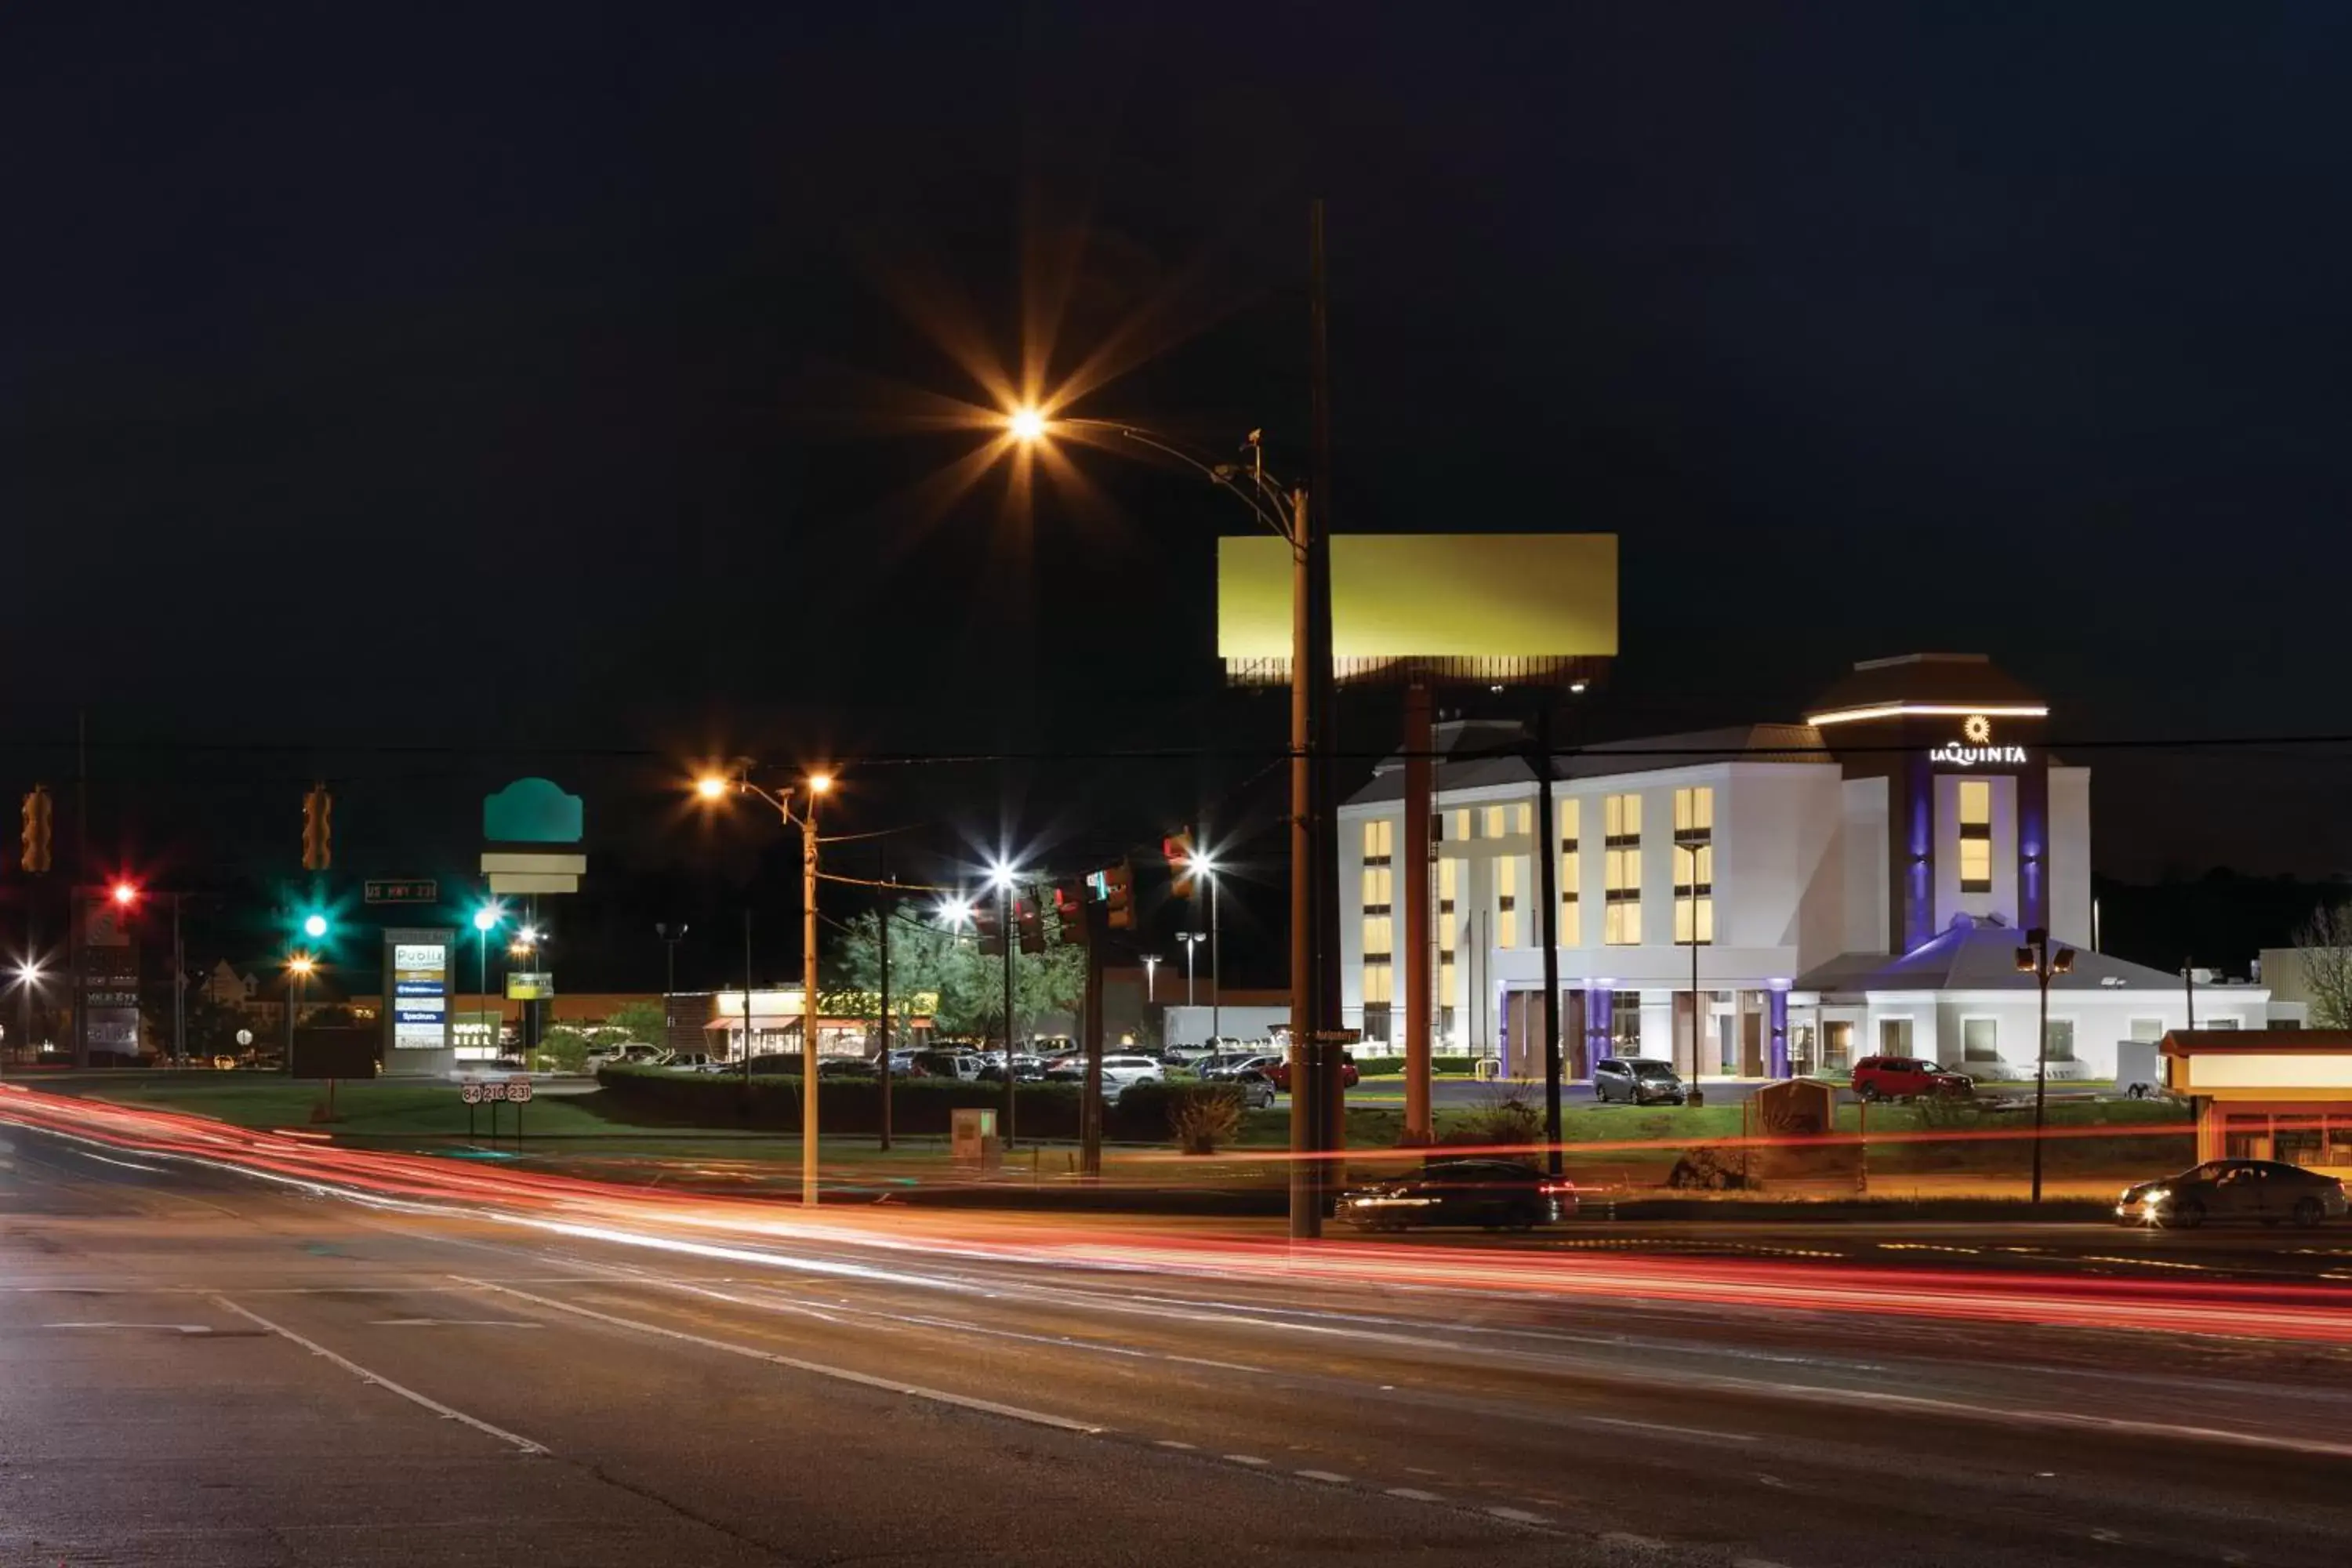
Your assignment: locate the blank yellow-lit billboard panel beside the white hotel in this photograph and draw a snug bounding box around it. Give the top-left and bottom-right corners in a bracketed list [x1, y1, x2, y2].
[1216, 534, 1618, 673]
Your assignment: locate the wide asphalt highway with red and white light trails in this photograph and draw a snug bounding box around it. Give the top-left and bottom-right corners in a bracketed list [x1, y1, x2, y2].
[0, 1093, 2352, 1568]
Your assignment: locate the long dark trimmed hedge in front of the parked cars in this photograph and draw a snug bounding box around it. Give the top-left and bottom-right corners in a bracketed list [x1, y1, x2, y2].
[595, 1067, 1240, 1142]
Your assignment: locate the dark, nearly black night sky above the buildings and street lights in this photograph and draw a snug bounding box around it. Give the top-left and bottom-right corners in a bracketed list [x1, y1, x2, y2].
[0, 0, 2352, 982]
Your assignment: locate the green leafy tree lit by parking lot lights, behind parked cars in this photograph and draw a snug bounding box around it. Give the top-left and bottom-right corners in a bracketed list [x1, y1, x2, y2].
[826, 909, 1087, 1034]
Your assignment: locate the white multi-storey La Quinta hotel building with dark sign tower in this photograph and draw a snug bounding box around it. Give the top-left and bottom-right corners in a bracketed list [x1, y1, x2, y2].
[1338, 654, 2300, 1076]
